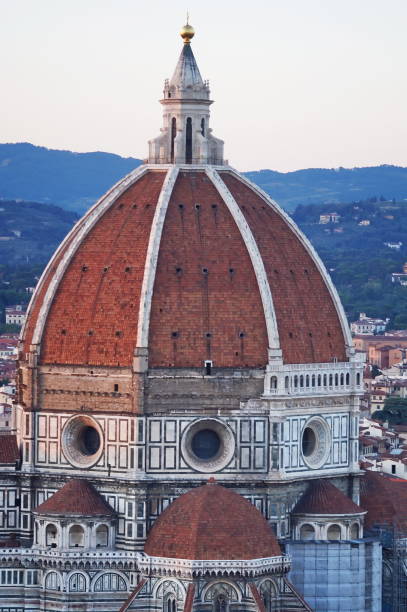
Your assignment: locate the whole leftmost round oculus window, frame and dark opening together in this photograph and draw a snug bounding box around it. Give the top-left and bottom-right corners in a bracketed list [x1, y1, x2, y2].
[62, 415, 103, 468]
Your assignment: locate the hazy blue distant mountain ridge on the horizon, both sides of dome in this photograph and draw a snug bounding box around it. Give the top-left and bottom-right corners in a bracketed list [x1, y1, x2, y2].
[0, 142, 407, 214]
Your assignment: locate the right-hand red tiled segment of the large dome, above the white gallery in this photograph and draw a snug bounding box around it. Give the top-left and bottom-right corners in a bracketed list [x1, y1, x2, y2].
[220, 171, 347, 363]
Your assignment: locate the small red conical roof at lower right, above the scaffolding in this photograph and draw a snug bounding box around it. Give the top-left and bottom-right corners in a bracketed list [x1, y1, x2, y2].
[293, 478, 364, 514]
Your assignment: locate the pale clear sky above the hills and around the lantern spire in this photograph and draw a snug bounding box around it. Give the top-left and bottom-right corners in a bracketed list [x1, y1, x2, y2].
[0, 0, 407, 171]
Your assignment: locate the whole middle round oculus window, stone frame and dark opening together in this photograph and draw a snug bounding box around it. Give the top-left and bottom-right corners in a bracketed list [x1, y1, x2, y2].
[181, 419, 235, 472]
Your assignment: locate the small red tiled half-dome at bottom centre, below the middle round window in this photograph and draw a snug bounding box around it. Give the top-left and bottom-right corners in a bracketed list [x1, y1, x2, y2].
[144, 483, 281, 560]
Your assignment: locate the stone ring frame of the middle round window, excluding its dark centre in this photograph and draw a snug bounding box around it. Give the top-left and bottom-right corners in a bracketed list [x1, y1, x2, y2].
[181, 417, 236, 473]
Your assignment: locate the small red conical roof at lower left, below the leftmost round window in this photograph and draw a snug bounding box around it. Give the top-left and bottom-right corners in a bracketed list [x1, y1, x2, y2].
[34, 478, 115, 516]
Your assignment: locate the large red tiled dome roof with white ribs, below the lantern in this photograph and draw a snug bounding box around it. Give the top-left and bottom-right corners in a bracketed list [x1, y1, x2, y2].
[23, 166, 350, 368]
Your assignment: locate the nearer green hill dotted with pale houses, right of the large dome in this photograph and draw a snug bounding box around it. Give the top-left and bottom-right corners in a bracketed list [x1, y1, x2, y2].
[293, 198, 407, 329]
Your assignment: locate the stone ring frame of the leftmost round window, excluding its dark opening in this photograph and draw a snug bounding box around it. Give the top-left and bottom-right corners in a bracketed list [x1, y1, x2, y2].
[61, 414, 104, 469]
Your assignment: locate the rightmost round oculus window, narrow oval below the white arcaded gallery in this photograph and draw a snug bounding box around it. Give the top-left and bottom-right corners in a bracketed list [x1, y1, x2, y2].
[301, 417, 331, 470]
